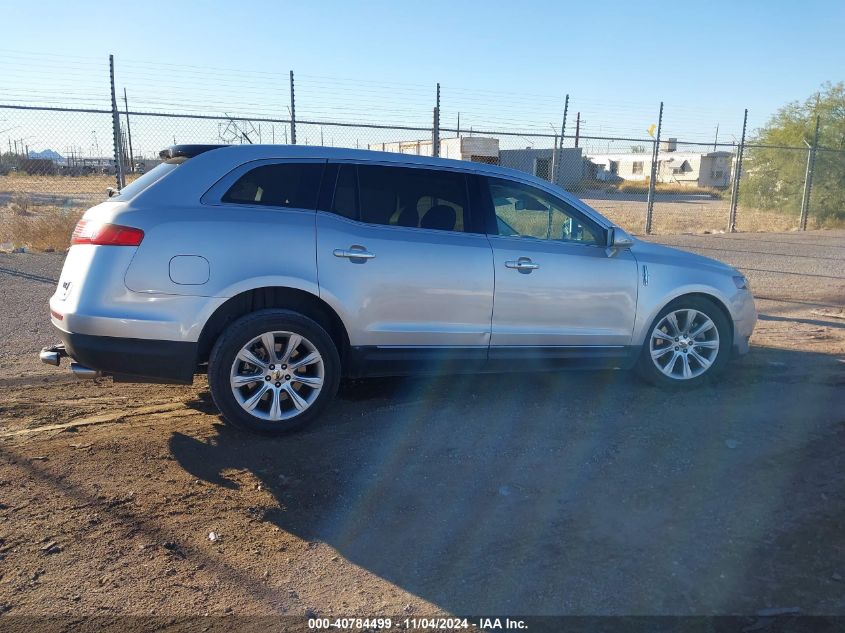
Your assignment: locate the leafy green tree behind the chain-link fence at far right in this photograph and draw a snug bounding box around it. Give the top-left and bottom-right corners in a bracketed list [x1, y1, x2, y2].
[740, 82, 845, 224]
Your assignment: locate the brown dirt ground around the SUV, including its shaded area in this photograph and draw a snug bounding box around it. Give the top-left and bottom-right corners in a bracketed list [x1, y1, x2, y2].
[0, 231, 845, 626]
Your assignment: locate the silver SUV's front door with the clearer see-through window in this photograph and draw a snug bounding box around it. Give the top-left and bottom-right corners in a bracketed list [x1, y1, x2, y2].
[484, 178, 637, 359]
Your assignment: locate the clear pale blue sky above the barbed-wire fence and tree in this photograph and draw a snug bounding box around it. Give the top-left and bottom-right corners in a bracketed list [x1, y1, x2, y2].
[0, 0, 845, 157]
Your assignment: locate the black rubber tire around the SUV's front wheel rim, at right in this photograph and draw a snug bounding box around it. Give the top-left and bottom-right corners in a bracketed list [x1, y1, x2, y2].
[635, 297, 733, 389]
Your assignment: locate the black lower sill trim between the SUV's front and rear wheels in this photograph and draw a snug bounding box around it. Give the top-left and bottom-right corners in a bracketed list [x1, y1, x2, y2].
[346, 345, 640, 378]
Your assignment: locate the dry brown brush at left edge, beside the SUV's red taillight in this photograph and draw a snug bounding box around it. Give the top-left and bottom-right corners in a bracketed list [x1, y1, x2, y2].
[0, 196, 84, 251]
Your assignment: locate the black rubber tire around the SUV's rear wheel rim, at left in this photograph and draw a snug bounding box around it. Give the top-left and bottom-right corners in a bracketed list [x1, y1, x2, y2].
[208, 309, 341, 435]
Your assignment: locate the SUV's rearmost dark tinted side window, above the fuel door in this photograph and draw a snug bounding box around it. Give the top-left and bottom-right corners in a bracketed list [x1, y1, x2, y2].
[223, 163, 324, 209]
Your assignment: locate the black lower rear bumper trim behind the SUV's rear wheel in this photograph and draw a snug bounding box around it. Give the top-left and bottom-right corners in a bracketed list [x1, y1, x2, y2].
[59, 330, 197, 384]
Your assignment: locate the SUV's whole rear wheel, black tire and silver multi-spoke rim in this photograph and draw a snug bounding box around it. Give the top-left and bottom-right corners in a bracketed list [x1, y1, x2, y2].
[208, 310, 340, 434]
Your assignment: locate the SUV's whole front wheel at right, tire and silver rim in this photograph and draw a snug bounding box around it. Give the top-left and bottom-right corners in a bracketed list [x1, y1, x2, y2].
[637, 297, 732, 387]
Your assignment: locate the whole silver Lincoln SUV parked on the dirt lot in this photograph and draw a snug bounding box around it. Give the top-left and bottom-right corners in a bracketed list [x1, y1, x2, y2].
[41, 145, 757, 433]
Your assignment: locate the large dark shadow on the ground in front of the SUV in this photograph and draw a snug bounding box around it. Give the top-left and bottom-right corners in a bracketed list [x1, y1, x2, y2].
[170, 348, 845, 615]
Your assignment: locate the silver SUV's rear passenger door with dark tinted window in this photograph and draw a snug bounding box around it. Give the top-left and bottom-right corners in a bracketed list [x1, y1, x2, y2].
[317, 163, 493, 370]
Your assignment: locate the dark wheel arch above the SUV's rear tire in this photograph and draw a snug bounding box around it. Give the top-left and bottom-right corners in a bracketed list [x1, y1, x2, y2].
[197, 286, 349, 365]
